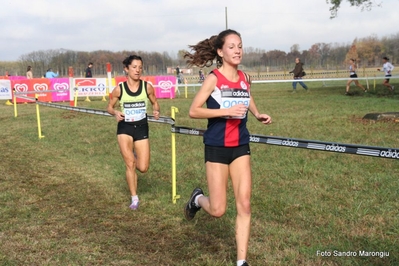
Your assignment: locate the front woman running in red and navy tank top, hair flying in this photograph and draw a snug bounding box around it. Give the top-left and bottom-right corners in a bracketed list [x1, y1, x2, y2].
[184, 30, 271, 266]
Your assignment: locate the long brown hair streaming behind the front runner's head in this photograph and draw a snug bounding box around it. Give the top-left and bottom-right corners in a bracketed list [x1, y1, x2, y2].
[184, 29, 241, 68]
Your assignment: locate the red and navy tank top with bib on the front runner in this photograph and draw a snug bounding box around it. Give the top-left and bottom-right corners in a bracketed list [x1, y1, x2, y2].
[204, 69, 250, 147]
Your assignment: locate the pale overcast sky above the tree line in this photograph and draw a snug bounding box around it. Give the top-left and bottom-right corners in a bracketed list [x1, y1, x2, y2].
[0, 0, 399, 61]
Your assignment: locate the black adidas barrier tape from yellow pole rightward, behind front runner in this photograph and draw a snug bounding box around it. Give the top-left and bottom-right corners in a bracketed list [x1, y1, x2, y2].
[171, 126, 399, 159]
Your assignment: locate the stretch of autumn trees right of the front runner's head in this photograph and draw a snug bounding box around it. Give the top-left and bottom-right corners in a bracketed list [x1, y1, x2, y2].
[242, 33, 399, 71]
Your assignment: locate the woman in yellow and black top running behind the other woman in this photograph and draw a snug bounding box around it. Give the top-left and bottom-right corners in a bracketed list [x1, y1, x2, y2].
[107, 55, 160, 210]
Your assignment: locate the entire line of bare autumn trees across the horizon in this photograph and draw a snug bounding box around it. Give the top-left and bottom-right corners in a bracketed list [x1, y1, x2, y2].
[0, 32, 399, 77]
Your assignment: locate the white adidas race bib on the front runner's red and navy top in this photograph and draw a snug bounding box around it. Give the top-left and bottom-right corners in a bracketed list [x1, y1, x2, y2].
[220, 89, 250, 119]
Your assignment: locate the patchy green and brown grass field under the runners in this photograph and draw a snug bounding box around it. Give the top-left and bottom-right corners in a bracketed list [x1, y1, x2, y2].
[0, 82, 399, 266]
